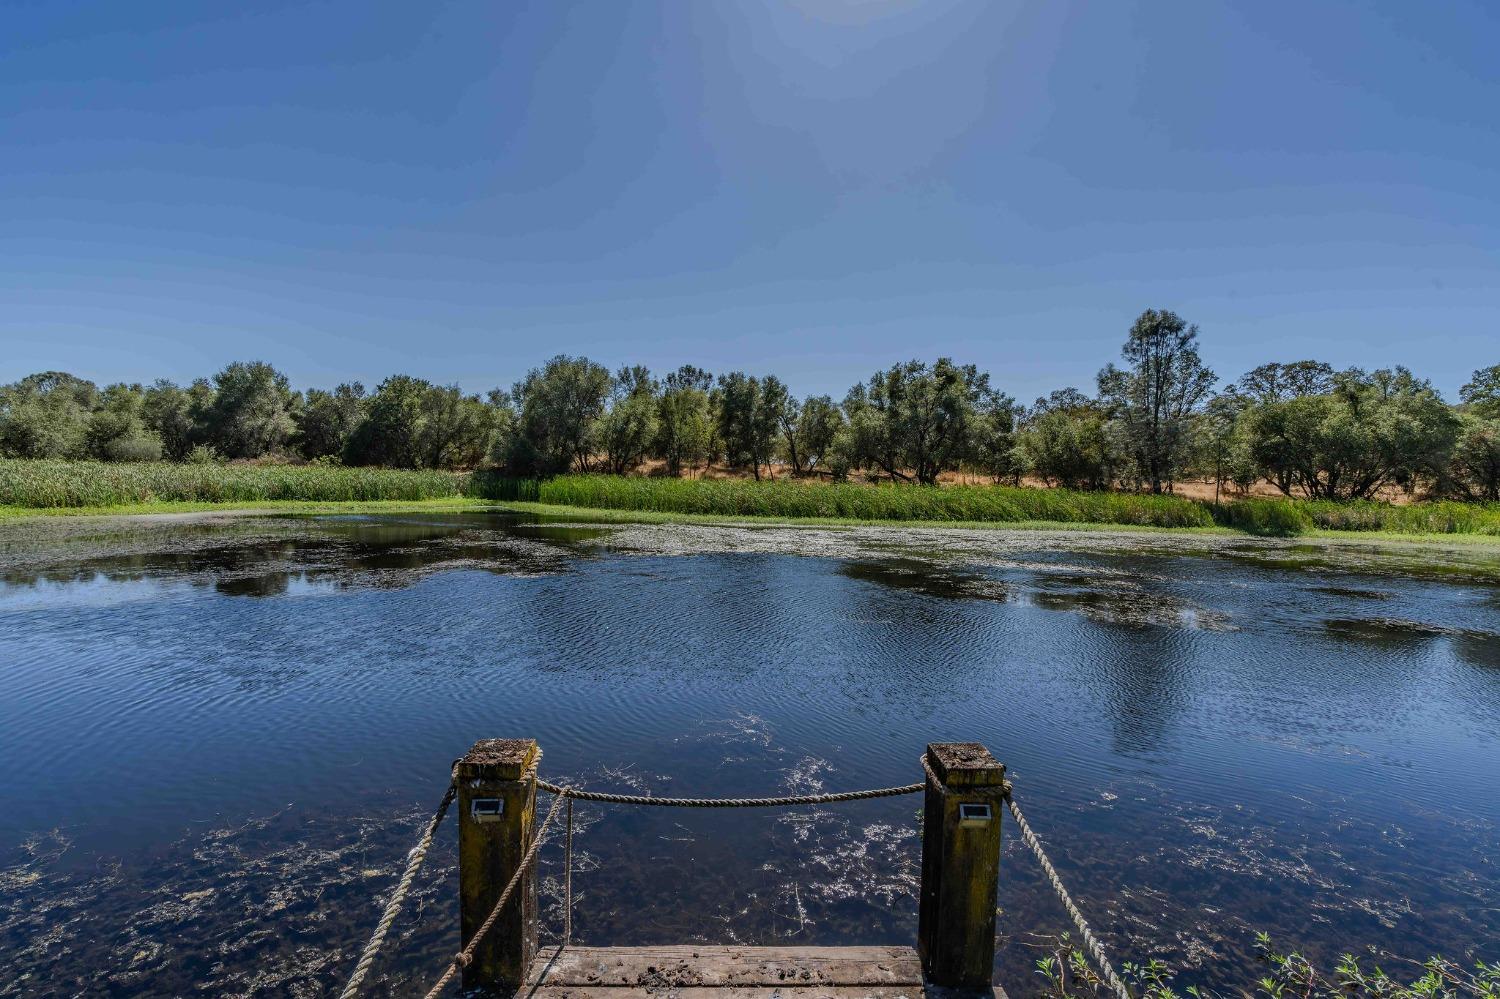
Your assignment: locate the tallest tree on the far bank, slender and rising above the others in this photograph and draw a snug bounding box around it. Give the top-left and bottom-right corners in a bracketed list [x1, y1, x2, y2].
[1098, 309, 1217, 492]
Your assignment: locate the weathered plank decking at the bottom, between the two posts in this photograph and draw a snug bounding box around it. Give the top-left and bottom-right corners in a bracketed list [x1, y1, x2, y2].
[521, 945, 1005, 999]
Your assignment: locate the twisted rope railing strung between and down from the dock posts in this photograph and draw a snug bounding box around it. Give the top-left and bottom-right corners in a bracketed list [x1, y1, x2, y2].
[339, 750, 1133, 999]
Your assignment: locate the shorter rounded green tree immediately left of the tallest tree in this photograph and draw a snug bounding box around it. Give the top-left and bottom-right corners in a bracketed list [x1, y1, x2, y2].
[1014, 389, 1116, 489]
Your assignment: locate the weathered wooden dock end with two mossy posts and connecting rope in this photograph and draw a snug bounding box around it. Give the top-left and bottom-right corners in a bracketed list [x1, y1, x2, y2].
[447, 740, 1005, 999]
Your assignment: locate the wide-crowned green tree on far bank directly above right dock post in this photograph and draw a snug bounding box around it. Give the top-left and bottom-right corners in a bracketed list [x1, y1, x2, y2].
[845, 357, 993, 485]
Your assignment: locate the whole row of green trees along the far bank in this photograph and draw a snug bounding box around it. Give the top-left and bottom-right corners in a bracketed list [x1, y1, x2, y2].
[0, 309, 1500, 501]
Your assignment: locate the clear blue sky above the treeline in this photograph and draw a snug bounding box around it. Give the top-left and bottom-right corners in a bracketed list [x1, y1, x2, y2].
[0, 0, 1500, 401]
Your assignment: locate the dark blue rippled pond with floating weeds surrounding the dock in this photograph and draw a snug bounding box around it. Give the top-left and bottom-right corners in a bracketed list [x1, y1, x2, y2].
[0, 513, 1500, 996]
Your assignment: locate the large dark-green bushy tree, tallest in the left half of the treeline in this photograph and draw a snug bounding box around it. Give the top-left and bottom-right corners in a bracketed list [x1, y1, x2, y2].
[509, 354, 611, 474]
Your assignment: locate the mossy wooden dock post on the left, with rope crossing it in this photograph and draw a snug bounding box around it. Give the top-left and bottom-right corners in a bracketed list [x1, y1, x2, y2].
[458, 740, 539, 995]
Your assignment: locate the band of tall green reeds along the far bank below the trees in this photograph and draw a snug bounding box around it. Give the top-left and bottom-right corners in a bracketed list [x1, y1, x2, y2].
[0, 461, 1500, 537]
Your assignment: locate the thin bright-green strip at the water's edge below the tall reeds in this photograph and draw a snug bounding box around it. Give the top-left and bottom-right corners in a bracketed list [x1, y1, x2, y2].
[0, 497, 1500, 551]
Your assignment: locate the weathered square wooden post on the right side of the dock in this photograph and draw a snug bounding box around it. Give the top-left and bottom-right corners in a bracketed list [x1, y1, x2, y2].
[917, 743, 1005, 989]
